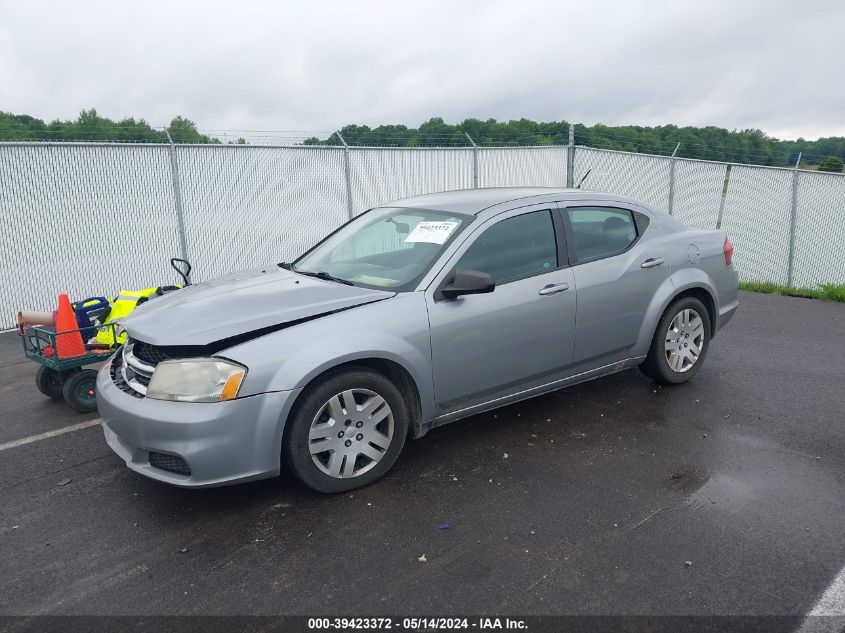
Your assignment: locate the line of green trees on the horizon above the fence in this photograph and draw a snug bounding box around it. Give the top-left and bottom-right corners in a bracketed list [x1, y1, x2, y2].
[0, 108, 845, 171]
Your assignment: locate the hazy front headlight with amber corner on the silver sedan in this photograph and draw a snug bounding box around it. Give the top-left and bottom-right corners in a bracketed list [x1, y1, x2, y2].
[147, 358, 246, 402]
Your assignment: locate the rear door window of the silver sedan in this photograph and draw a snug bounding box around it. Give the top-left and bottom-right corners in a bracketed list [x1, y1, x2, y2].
[566, 207, 637, 263]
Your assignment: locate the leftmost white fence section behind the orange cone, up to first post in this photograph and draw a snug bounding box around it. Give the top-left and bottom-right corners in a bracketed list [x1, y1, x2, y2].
[0, 144, 179, 329]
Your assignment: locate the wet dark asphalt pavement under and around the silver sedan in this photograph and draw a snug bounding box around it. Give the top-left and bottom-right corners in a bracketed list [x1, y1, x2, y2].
[0, 293, 845, 616]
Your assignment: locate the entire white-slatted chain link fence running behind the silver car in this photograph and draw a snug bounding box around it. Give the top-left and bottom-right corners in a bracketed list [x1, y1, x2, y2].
[0, 137, 845, 328]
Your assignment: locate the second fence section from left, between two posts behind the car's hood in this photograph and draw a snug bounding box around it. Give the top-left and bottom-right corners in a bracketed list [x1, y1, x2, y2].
[176, 145, 348, 284]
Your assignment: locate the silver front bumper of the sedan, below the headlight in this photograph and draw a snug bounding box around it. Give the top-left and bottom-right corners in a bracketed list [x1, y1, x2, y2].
[97, 365, 298, 488]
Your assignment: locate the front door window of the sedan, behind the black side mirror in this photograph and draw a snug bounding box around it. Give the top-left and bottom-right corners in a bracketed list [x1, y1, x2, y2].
[455, 211, 558, 285]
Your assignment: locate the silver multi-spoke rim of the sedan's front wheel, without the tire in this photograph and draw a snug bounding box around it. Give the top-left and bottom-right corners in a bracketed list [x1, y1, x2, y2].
[308, 389, 394, 479]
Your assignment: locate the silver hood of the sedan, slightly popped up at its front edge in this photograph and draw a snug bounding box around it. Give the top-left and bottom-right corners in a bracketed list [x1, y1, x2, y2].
[125, 266, 396, 346]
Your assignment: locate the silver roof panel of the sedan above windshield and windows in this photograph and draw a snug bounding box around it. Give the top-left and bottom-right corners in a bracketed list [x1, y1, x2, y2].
[379, 187, 646, 215]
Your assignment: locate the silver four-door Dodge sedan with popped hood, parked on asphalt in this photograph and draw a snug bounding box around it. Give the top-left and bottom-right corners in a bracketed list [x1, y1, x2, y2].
[97, 188, 738, 492]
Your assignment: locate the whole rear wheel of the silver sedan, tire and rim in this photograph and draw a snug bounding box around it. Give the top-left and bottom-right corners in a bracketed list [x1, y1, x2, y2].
[640, 297, 711, 385]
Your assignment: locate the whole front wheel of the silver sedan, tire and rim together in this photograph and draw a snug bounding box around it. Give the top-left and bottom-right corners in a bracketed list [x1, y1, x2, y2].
[283, 368, 409, 493]
